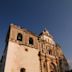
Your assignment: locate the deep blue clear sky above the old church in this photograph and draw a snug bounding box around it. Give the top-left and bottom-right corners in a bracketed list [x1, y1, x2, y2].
[0, 0, 72, 66]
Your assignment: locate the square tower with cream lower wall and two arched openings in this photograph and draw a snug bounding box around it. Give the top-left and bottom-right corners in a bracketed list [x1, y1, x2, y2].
[3, 24, 40, 72]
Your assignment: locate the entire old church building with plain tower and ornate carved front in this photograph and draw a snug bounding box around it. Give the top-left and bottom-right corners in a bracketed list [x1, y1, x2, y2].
[0, 24, 69, 72]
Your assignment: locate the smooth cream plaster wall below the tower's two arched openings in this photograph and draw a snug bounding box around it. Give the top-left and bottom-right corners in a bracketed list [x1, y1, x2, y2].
[4, 41, 40, 72]
